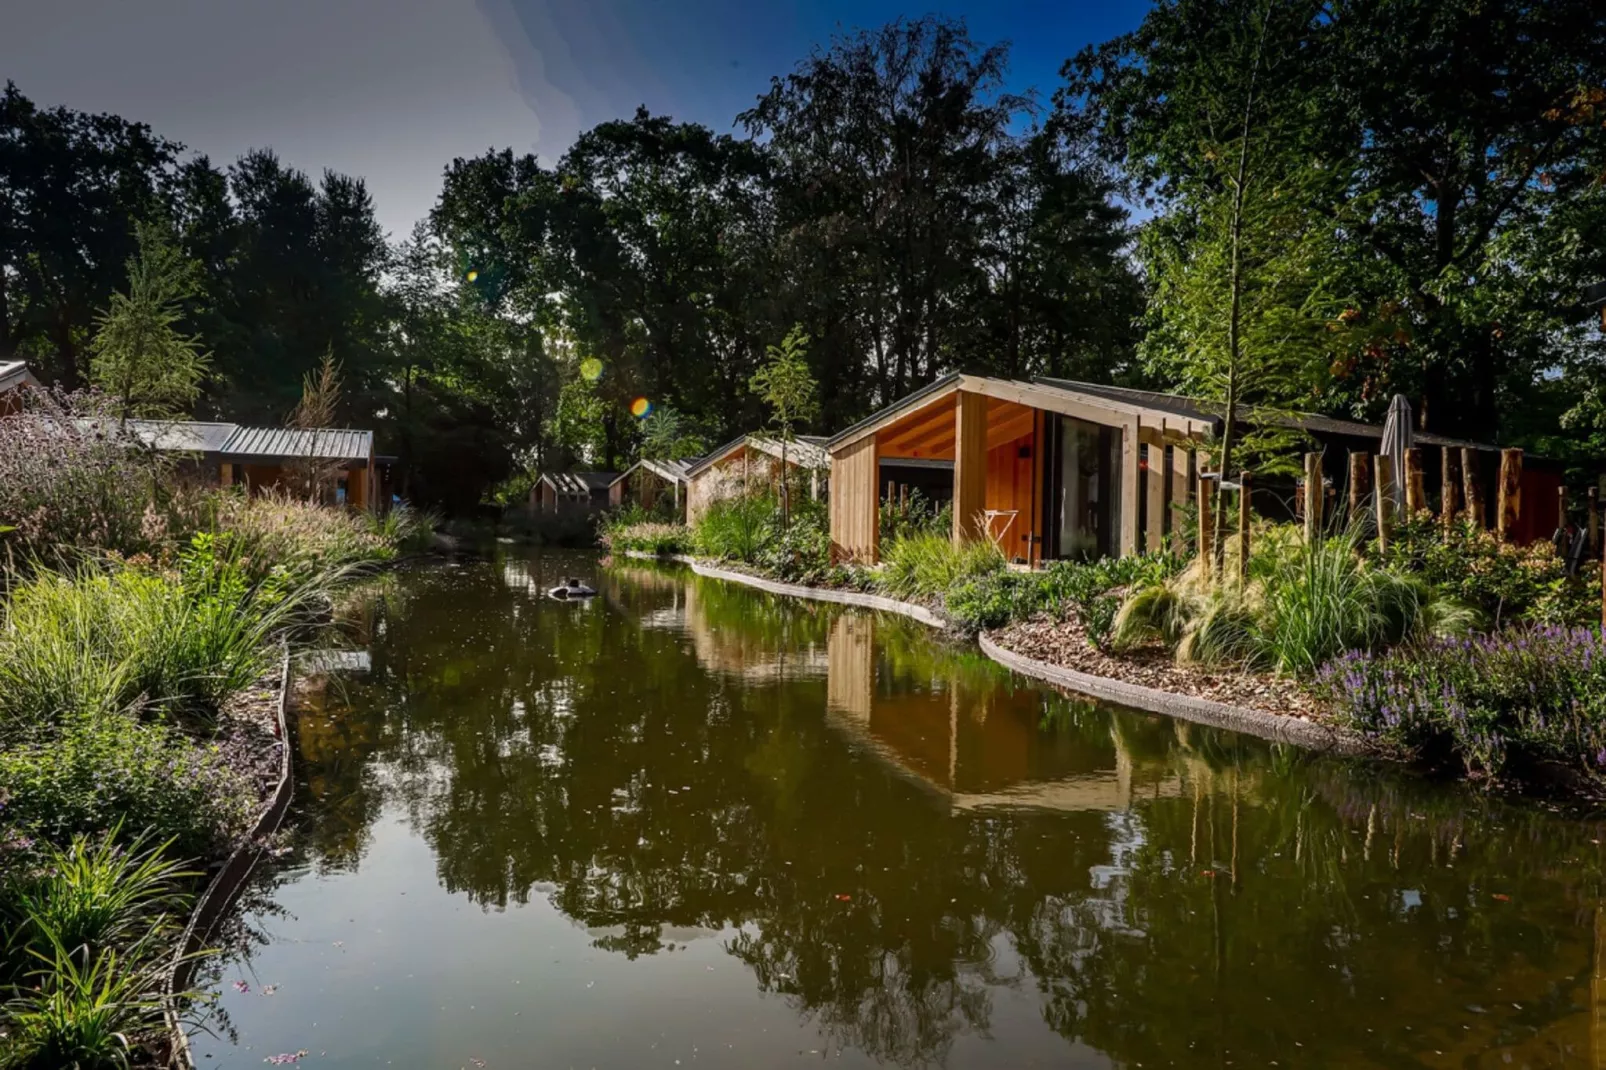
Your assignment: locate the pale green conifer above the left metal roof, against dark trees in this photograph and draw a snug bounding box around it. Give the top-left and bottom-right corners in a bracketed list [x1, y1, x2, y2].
[90, 223, 210, 421]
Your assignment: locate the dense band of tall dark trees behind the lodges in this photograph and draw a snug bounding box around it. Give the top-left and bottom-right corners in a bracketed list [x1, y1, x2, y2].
[0, 0, 1606, 509]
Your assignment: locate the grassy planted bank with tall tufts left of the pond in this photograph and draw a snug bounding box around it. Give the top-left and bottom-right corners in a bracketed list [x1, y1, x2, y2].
[0, 401, 427, 1070]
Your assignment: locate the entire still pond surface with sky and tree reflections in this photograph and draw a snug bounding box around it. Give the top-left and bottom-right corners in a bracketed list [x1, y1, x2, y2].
[198, 554, 1606, 1068]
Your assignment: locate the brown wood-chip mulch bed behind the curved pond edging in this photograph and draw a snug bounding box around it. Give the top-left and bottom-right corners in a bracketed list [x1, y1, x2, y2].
[991, 617, 1331, 723]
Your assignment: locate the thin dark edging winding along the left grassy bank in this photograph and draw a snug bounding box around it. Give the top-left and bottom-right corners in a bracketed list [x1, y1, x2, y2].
[162, 643, 296, 1070]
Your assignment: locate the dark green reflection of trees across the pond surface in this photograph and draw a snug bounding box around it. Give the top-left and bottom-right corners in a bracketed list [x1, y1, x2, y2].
[285, 552, 1601, 1065]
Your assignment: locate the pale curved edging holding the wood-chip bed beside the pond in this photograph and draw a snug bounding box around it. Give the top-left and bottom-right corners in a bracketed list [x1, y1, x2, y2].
[978, 635, 1373, 753]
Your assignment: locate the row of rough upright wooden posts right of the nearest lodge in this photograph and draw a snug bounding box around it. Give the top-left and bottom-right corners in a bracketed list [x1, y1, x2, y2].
[1198, 447, 1606, 628]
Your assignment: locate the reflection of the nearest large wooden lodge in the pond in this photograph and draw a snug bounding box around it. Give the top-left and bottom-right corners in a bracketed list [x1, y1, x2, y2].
[825, 614, 1182, 810]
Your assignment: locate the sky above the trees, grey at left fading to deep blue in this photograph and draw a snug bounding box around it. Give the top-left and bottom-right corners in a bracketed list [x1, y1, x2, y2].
[0, 0, 1147, 236]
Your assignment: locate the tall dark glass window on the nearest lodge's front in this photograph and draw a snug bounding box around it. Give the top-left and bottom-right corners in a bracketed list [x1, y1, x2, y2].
[1044, 416, 1121, 561]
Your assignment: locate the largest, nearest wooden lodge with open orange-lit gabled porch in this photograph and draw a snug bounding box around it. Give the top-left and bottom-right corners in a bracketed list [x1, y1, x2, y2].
[824, 374, 1561, 566]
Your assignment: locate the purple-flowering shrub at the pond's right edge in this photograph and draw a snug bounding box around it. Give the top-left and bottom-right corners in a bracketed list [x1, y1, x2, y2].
[1319, 625, 1606, 778]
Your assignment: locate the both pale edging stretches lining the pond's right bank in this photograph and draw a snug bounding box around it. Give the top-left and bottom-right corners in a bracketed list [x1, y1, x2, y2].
[625, 551, 1361, 755]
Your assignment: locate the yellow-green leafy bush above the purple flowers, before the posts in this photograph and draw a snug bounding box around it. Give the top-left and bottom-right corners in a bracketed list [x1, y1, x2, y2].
[1386, 513, 1601, 627]
